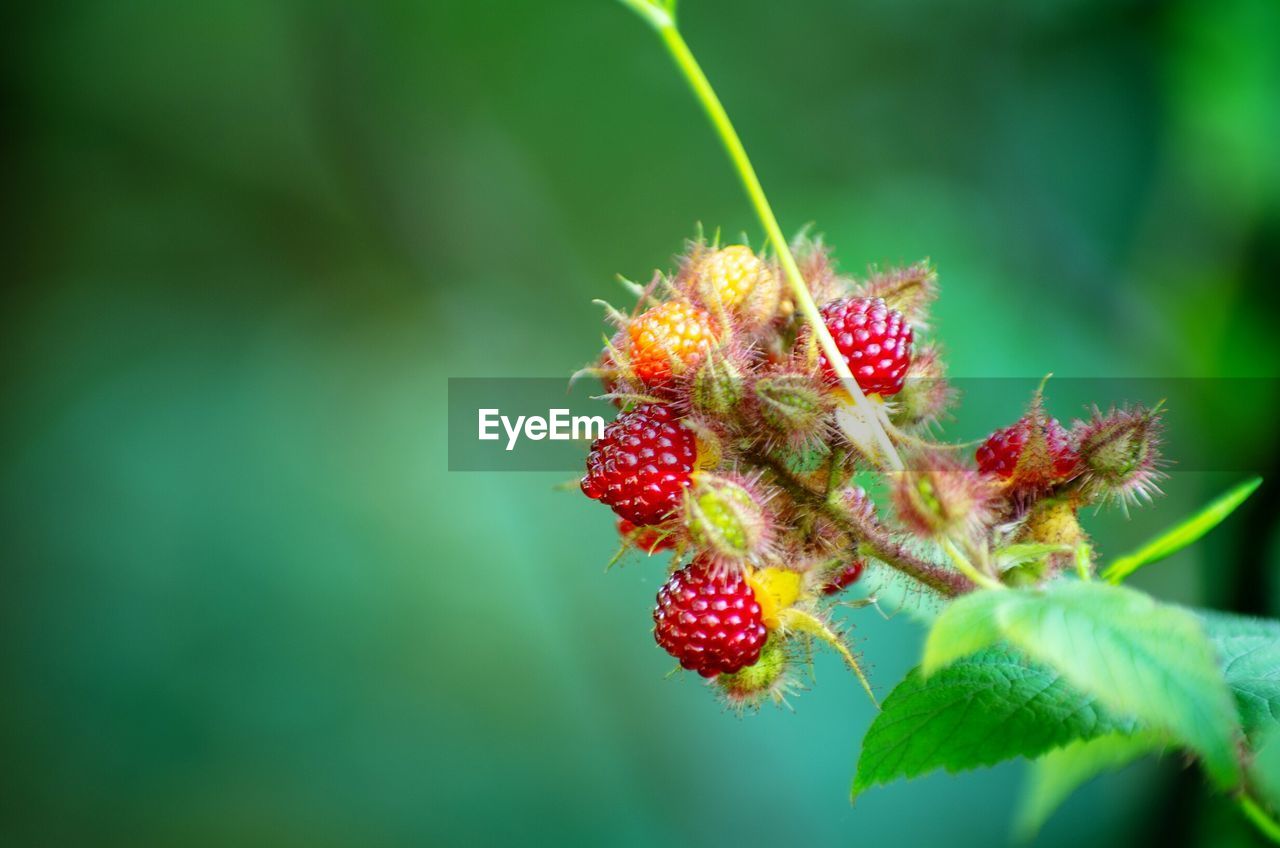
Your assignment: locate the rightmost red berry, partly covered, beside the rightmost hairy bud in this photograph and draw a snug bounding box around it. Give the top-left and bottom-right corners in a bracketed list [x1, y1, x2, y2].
[974, 412, 1079, 492]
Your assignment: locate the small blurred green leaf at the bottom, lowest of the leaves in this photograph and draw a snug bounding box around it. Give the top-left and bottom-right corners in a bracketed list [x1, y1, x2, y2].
[1014, 731, 1166, 840]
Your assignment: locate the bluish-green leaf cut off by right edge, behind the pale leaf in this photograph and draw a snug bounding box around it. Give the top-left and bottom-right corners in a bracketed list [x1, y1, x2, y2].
[1199, 612, 1280, 747]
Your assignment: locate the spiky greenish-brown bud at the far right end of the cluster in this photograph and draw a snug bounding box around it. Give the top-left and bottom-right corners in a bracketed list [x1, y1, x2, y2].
[1074, 406, 1165, 509]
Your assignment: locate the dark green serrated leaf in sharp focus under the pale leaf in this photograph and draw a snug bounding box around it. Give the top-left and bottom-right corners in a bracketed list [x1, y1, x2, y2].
[852, 648, 1135, 797]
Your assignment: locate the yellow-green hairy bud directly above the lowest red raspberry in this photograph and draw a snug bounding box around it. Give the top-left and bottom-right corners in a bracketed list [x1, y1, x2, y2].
[685, 474, 771, 566]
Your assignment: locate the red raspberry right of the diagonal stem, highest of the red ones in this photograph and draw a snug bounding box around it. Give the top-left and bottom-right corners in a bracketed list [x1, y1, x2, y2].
[818, 297, 911, 397]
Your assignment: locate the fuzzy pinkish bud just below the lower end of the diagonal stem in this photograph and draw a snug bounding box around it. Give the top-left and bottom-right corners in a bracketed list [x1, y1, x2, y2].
[892, 452, 991, 538]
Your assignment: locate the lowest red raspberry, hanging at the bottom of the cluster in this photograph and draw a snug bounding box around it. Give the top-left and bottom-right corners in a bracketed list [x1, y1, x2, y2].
[653, 557, 768, 678]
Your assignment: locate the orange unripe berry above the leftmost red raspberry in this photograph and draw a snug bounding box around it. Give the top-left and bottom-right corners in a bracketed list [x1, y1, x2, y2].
[627, 300, 717, 389]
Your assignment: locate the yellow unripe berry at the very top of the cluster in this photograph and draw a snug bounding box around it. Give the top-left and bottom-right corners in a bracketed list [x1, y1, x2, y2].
[690, 245, 782, 329]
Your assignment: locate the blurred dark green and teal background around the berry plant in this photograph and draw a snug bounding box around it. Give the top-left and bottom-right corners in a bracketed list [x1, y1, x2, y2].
[0, 0, 1280, 848]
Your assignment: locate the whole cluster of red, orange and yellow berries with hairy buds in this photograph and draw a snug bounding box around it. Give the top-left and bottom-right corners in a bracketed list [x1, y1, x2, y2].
[581, 235, 1160, 707]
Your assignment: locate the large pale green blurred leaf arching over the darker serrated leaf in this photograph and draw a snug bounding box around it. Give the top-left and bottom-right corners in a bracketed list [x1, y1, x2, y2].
[922, 580, 1240, 787]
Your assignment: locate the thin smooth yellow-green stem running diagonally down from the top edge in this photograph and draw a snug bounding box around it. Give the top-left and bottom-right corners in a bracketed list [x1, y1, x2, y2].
[622, 0, 902, 471]
